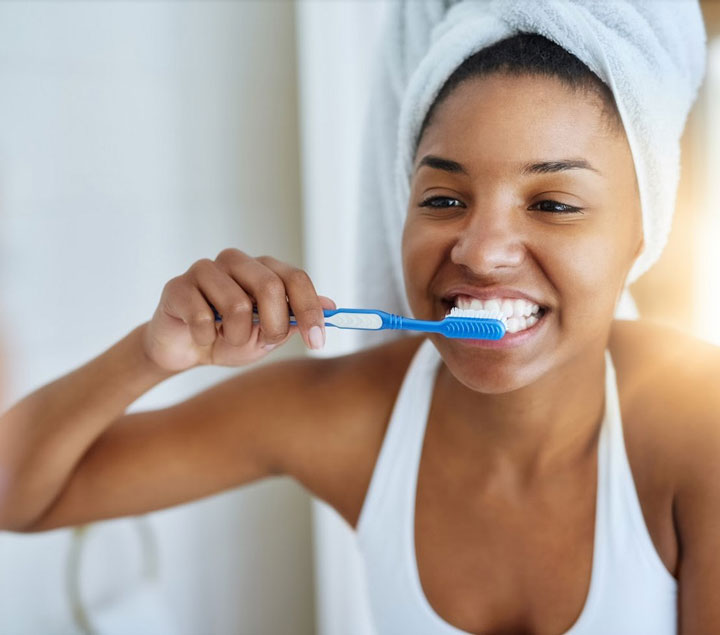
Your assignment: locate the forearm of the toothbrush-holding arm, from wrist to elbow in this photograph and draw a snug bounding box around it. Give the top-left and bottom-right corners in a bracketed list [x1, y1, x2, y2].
[0, 324, 174, 530]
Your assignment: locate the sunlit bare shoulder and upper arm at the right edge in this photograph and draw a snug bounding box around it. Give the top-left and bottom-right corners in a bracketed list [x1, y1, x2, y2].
[610, 320, 720, 604]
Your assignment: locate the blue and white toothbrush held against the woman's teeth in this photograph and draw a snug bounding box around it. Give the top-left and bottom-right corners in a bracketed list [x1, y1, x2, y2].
[210, 304, 507, 340]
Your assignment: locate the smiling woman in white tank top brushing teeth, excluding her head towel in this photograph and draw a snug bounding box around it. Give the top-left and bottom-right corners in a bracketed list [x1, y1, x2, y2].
[0, 35, 720, 635]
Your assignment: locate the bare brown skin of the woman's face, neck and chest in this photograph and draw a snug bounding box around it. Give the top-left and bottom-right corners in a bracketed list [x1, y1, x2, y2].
[403, 75, 642, 633]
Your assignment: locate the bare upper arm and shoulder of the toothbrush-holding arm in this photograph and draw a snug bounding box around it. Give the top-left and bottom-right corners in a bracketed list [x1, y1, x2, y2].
[16, 338, 420, 531]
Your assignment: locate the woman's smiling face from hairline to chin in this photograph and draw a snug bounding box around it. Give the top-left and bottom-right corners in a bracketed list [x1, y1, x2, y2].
[402, 74, 642, 393]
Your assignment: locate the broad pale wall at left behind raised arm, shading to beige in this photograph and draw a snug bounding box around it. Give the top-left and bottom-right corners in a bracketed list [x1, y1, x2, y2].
[0, 2, 314, 635]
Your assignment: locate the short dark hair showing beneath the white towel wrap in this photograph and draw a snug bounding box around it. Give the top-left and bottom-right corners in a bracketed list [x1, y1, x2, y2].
[415, 33, 623, 148]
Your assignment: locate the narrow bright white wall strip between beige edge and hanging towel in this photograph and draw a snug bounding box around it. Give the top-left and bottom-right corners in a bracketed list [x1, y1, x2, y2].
[297, 0, 388, 635]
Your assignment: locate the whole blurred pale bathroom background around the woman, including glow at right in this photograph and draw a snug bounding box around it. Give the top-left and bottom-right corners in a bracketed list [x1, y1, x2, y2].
[0, 0, 720, 635]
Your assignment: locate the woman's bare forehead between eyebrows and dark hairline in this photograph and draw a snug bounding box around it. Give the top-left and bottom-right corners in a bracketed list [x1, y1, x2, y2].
[415, 74, 633, 176]
